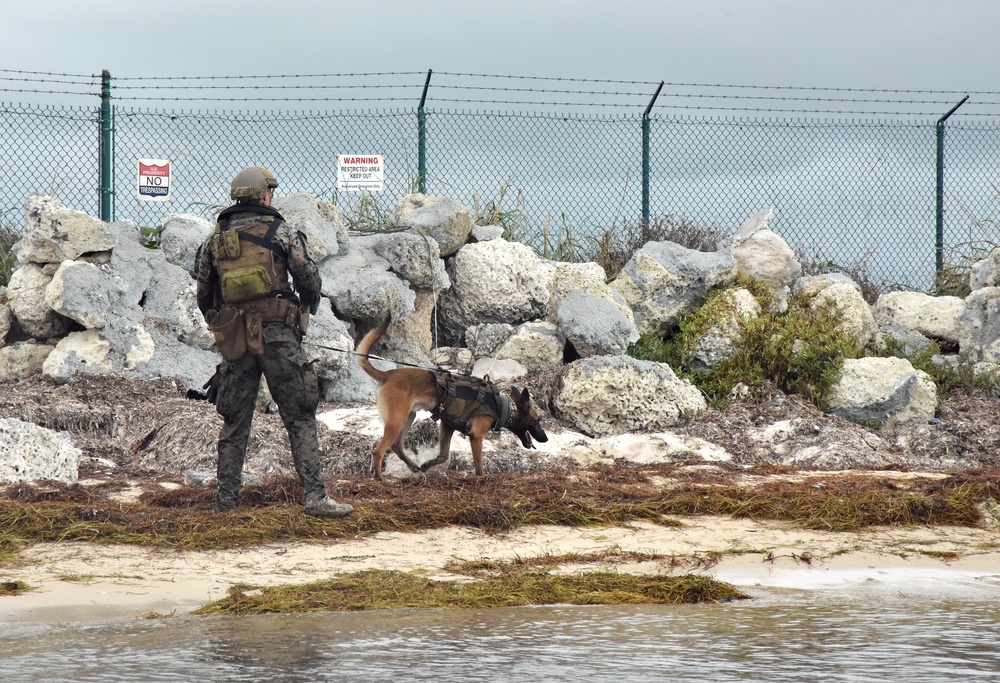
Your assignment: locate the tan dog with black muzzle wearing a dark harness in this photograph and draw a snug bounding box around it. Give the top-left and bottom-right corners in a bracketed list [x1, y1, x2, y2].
[355, 320, 549, 481]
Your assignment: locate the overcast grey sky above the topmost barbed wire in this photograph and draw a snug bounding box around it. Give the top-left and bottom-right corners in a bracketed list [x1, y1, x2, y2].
[0, 0, 1000, 91]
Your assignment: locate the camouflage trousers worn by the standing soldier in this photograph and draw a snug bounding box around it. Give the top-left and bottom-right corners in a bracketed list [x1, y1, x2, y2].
[215, 323, 326, 510]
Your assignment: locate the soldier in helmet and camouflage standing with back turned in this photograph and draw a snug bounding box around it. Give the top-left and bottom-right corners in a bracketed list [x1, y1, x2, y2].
[193, 166, 353, 517]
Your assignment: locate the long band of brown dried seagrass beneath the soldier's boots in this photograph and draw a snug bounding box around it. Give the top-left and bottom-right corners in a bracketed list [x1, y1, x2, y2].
[0, 466, 1000, 552]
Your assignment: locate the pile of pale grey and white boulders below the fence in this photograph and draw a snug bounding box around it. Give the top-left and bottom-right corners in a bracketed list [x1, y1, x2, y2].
[0, 194, 1000, 481]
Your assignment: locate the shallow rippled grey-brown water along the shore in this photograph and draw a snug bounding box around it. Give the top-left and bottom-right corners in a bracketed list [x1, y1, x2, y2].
[0, 592, 1000, 683]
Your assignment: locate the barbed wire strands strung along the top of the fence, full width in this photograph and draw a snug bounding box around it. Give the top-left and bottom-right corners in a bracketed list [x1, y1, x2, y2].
[7, 69, 1000, 117]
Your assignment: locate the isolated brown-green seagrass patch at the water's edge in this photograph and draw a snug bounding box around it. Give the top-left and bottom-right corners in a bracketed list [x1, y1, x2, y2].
[197, 568, 749, 615]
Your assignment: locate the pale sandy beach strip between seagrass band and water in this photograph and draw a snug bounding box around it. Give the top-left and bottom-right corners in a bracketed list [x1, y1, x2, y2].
[0, 517, 1000, 623]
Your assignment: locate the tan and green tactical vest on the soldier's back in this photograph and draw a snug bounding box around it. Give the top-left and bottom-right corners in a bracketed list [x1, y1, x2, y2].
[210, 207, 291, 304]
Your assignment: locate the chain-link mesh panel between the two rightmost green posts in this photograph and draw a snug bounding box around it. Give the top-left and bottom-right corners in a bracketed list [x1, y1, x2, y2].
[651, 118, 936, 289]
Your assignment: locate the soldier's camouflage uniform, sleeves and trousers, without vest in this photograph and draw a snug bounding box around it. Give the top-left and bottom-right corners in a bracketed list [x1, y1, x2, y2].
[192, 203, 326, 511]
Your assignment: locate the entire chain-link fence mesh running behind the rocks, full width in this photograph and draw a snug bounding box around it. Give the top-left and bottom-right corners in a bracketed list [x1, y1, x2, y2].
[0, 99, 1000, 290]
